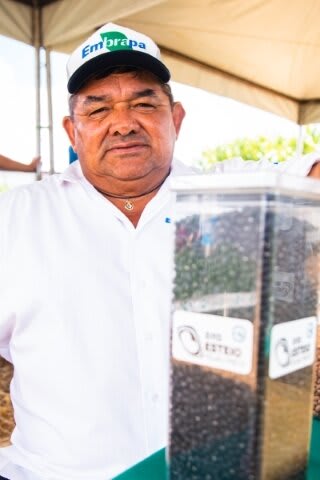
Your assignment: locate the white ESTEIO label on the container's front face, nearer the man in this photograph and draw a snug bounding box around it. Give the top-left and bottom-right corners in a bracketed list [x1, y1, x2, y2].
[172, 310, 253, 375]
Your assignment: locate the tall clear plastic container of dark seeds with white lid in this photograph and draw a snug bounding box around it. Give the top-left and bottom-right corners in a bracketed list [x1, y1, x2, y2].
[167, 172, 320, 480]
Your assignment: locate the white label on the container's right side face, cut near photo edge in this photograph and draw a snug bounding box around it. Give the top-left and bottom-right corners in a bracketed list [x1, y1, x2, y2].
[269, 317, 317, 378]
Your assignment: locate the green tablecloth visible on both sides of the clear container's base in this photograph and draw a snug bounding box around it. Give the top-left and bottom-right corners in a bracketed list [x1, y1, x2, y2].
[114, 419, 320, 480]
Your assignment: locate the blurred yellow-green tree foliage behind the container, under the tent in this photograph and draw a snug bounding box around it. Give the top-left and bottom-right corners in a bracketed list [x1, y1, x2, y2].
[199, 125, 320, 170]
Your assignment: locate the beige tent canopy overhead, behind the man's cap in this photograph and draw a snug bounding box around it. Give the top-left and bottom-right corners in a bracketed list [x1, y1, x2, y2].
[0, 0, 320, 124]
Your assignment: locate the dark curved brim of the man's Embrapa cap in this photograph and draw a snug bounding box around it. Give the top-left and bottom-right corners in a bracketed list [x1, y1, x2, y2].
[68, 50, 170, 93]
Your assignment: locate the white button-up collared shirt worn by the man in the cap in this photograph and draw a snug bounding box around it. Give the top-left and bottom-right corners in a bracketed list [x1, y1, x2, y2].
[0, 162, 195, 480]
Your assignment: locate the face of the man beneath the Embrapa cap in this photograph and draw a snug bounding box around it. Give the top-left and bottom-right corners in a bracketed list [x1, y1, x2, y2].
[64, 73, 184, 190]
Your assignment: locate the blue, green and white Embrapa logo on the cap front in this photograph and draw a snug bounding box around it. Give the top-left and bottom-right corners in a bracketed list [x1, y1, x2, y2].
[82, 32, 146, 58]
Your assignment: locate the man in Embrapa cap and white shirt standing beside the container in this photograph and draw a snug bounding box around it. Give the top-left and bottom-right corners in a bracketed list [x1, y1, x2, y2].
[0, 24, 313, 480]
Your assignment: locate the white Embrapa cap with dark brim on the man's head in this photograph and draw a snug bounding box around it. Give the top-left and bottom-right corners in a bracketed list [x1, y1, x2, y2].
[67, 23, 170, 93]
